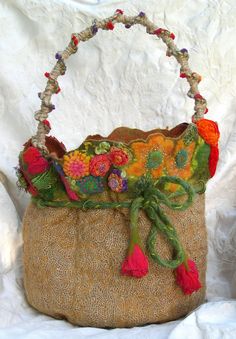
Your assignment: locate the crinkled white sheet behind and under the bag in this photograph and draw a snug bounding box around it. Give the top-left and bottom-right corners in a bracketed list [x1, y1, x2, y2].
[0, 0, 236, 339]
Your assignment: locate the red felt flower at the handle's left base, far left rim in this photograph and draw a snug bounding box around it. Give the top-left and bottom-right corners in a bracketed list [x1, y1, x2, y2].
[22, 146, 49, 175]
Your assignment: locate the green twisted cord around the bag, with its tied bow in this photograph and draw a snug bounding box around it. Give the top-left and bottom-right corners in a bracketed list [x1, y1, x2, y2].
[33, 176, 195, 269]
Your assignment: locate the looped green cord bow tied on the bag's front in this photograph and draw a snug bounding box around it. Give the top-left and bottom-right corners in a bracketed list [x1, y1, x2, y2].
[129, 176, 195, 269]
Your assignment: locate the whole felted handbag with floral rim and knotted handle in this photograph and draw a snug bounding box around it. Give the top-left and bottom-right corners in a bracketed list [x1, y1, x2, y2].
[17, 10, 219, 327]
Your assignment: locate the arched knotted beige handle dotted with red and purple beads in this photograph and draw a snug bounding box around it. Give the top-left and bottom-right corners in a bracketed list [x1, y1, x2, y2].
[32, 9, 208, 153]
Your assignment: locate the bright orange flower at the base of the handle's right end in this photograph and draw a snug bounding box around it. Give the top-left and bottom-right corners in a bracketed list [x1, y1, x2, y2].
[196, 119, 220, 146]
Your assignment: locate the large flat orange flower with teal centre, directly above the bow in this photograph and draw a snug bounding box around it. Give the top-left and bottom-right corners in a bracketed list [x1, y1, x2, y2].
[126, 134, 174, 178]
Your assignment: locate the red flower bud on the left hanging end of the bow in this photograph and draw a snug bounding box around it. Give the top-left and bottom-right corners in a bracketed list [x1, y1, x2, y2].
[121, 244, 148, 278]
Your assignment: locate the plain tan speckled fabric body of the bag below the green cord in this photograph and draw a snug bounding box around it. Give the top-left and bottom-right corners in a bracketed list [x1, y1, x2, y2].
[23, 195, 207, 327]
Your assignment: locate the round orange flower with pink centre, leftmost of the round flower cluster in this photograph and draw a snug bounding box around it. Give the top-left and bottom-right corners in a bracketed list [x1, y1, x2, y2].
[63, 151, 90, 179]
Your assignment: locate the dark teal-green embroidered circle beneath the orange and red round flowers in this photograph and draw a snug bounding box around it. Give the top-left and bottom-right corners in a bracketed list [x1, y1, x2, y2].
[76, 175, 104, 194]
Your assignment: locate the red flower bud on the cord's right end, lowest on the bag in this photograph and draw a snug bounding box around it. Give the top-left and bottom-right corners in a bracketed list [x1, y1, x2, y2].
[175, 259, 202, 294]
